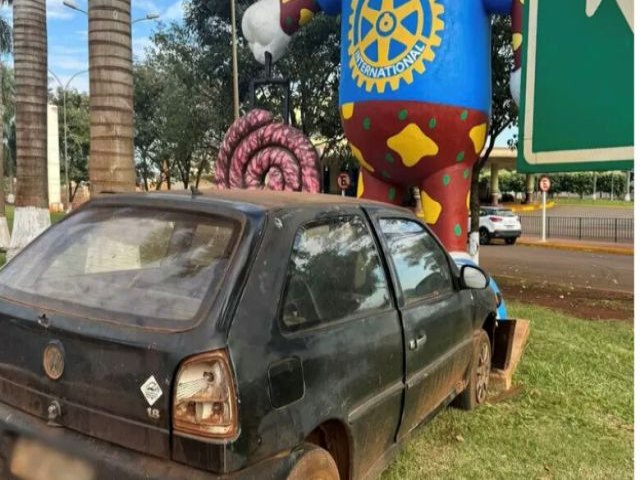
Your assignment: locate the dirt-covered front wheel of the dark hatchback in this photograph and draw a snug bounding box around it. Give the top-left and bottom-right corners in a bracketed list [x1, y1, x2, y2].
[453, 330, 491, 410]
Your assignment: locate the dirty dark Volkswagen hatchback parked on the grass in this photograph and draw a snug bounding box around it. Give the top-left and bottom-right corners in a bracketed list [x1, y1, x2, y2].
[0, 191, 496, 480]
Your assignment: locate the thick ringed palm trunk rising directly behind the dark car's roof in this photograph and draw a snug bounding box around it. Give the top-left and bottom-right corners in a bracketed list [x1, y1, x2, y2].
[89, 0, 135, 195]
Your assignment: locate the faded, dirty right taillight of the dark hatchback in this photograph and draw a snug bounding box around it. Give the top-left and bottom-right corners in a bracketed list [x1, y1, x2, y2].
[173, 351, 238, 440]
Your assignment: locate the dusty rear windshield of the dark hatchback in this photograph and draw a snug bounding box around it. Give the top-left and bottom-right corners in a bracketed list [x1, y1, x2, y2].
[0, 207, 239, 326]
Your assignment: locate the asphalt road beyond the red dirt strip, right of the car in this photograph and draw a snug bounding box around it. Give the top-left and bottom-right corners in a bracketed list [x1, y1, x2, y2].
[480, 245, 633, 293]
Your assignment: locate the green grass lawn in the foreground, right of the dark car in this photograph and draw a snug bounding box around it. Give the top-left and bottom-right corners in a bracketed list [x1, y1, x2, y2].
[382, 302, 633, 480]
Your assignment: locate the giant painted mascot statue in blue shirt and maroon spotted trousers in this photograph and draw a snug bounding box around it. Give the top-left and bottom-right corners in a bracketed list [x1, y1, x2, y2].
[242, 0, 522, 251]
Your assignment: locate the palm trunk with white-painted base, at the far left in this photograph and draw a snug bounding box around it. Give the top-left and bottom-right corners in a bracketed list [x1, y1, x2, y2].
[8, 0, 51, 257]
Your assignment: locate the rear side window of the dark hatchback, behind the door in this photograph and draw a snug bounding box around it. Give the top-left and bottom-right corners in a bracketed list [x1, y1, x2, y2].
[282, 215, 390, 330]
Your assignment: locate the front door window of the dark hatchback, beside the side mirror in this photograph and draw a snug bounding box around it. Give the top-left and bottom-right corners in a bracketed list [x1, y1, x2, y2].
[379, 218, 453, 303]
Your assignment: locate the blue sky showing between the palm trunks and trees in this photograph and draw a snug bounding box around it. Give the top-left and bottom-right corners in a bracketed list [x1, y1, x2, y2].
[0, 0, 183, 91]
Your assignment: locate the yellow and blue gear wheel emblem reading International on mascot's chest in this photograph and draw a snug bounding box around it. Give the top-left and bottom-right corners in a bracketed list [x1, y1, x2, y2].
[349, 0, 444, 93]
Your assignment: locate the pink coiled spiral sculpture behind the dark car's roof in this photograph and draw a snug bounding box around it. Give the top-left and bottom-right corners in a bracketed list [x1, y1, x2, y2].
[213, 109, 320, 193]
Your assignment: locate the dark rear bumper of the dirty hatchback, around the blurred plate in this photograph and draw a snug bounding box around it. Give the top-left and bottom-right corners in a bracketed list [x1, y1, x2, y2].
[0, 402, 296, 480]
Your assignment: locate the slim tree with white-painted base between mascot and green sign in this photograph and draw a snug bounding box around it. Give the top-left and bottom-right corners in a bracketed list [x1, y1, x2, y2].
[469, 16, 518, 256]
